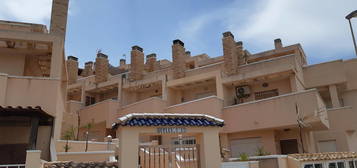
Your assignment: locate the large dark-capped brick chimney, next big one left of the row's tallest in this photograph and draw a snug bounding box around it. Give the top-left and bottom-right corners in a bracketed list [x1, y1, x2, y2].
[172, 39, 187, 79]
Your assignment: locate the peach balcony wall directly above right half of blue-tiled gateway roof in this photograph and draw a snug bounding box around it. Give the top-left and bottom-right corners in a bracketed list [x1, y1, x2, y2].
[166, 96, 223, 118]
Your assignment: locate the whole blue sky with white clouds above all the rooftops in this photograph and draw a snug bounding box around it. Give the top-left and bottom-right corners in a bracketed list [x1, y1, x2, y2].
[0, 0, 357, 66]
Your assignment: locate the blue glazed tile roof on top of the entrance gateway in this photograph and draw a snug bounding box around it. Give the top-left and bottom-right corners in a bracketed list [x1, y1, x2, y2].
[112, 113, 224, 129]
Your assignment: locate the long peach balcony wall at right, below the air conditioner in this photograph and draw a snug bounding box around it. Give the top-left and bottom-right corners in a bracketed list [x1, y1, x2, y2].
[223, 89, 329, 132]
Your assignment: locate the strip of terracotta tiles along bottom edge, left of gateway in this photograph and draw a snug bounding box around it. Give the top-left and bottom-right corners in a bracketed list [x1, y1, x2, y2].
[43, 162, 118, 168]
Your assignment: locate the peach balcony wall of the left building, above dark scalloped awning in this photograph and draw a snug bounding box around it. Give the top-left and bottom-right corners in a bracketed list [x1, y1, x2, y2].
[0, 74, 63, 116]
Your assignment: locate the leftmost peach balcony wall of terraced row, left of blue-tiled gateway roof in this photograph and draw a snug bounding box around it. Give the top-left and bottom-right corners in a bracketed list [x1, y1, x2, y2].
[79, 99, 119, 128]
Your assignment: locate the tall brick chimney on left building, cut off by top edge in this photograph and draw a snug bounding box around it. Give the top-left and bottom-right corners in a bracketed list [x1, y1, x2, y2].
[50, 0, 69, 39]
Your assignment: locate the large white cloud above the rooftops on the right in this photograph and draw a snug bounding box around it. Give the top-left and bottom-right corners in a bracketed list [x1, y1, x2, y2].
[181, 0, 357, 59]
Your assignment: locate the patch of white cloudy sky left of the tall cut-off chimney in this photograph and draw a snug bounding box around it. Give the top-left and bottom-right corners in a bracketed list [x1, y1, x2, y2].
[0, 0, 52, 24]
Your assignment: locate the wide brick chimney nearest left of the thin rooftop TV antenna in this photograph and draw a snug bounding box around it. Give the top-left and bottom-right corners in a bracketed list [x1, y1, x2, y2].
[94, 52, 109, 83]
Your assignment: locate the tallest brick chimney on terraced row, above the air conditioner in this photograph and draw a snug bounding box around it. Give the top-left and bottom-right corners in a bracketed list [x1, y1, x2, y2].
[222, 32, 238, 75]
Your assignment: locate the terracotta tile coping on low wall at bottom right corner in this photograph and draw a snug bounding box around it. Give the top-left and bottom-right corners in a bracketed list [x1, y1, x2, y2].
[288, 152, 357, 161]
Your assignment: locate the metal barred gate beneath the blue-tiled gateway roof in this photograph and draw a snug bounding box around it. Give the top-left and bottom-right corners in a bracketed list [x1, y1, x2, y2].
[139, 144, 200, 168]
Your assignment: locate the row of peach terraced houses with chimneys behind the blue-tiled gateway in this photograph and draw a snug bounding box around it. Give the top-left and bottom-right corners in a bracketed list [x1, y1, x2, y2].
[62, 32, 357, 157]
